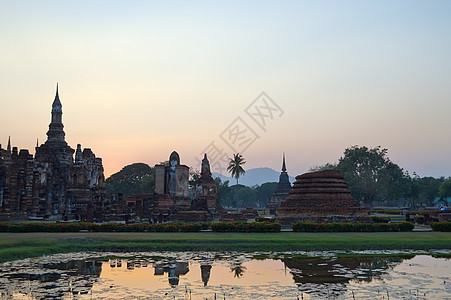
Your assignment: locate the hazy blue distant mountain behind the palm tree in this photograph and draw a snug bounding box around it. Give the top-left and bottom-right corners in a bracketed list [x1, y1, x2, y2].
[212, 168, 295, 186]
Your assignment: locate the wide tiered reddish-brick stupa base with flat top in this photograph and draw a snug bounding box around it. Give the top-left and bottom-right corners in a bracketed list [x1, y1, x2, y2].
[277, 170, 371, 224]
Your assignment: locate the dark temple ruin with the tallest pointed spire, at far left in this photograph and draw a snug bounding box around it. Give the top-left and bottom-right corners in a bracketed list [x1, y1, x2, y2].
[0, 86, 106, 220]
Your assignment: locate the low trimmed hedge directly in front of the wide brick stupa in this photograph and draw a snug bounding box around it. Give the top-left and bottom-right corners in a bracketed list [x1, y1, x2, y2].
[292, 222, 414, 232]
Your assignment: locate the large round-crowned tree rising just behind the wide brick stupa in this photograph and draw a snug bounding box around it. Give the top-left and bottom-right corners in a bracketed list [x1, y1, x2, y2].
[337, 146, 406, 207]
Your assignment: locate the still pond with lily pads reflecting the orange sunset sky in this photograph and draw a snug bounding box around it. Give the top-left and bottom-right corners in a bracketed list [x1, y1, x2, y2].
[0, 252, 451, 300]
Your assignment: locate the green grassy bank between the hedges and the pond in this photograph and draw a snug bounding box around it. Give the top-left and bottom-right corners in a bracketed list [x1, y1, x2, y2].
[0, 232, 451, 261]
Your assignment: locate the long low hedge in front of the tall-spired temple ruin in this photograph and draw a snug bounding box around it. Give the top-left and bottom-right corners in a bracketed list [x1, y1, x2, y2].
[0, 222, 209, 232]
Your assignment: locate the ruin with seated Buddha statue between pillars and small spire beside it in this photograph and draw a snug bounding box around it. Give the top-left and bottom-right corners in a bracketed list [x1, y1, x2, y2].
[124, 151, 225, 223]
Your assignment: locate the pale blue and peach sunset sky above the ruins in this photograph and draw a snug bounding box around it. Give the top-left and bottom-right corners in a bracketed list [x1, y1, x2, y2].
[0, 0, 451, 177]
